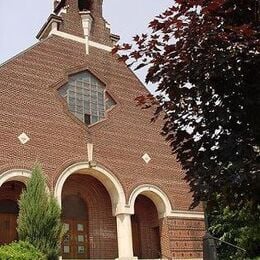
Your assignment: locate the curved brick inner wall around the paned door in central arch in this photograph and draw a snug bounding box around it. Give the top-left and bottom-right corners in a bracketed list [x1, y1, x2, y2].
[62, 174, 118, 259]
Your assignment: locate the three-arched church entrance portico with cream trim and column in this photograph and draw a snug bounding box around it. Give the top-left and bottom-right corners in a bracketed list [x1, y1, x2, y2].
[0, 162, 199, 260]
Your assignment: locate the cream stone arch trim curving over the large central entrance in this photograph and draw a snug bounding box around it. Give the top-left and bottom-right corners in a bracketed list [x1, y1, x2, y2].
[54, 162, 126, 216]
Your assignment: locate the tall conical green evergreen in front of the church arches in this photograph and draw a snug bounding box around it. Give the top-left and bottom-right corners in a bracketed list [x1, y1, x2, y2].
[18, 165, 63, 260]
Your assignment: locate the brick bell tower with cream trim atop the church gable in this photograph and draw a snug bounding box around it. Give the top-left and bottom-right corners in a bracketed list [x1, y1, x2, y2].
[37, 0, 119, 54]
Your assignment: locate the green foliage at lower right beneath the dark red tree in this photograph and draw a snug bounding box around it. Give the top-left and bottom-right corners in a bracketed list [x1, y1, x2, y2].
[208, 199, 260, 260]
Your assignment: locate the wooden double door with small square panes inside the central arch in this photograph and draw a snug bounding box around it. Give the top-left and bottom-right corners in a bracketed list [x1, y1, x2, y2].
[62, 219, 89, 259]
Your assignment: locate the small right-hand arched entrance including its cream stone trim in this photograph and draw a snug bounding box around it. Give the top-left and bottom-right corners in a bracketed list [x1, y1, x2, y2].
[128, 184, 172, 259]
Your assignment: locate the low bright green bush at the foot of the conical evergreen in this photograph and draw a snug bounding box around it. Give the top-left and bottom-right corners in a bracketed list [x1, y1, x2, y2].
[0, 241, 46, 260]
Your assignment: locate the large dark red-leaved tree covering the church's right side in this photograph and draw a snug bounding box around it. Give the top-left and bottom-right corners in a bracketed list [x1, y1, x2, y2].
[114, 0, 260, 255]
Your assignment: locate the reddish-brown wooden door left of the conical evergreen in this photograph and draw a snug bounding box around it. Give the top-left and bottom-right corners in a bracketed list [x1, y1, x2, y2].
[0, 213, 18, 245]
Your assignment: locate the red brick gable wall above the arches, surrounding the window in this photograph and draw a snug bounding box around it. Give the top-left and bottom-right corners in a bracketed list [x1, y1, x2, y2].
[0, 36, 197, 210]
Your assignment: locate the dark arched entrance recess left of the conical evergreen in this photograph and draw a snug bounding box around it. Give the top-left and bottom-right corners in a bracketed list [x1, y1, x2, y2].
[0, 181, 25, 245]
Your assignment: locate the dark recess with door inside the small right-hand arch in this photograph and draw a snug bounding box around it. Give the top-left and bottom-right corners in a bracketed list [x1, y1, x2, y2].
[132, 195, 161, 259]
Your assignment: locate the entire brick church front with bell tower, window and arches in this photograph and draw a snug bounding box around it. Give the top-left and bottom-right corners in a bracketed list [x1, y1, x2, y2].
[0, 0, 204, 260]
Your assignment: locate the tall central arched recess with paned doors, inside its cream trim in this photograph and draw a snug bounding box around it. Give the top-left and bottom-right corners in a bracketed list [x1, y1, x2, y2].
[62, 173, 118, 259]
